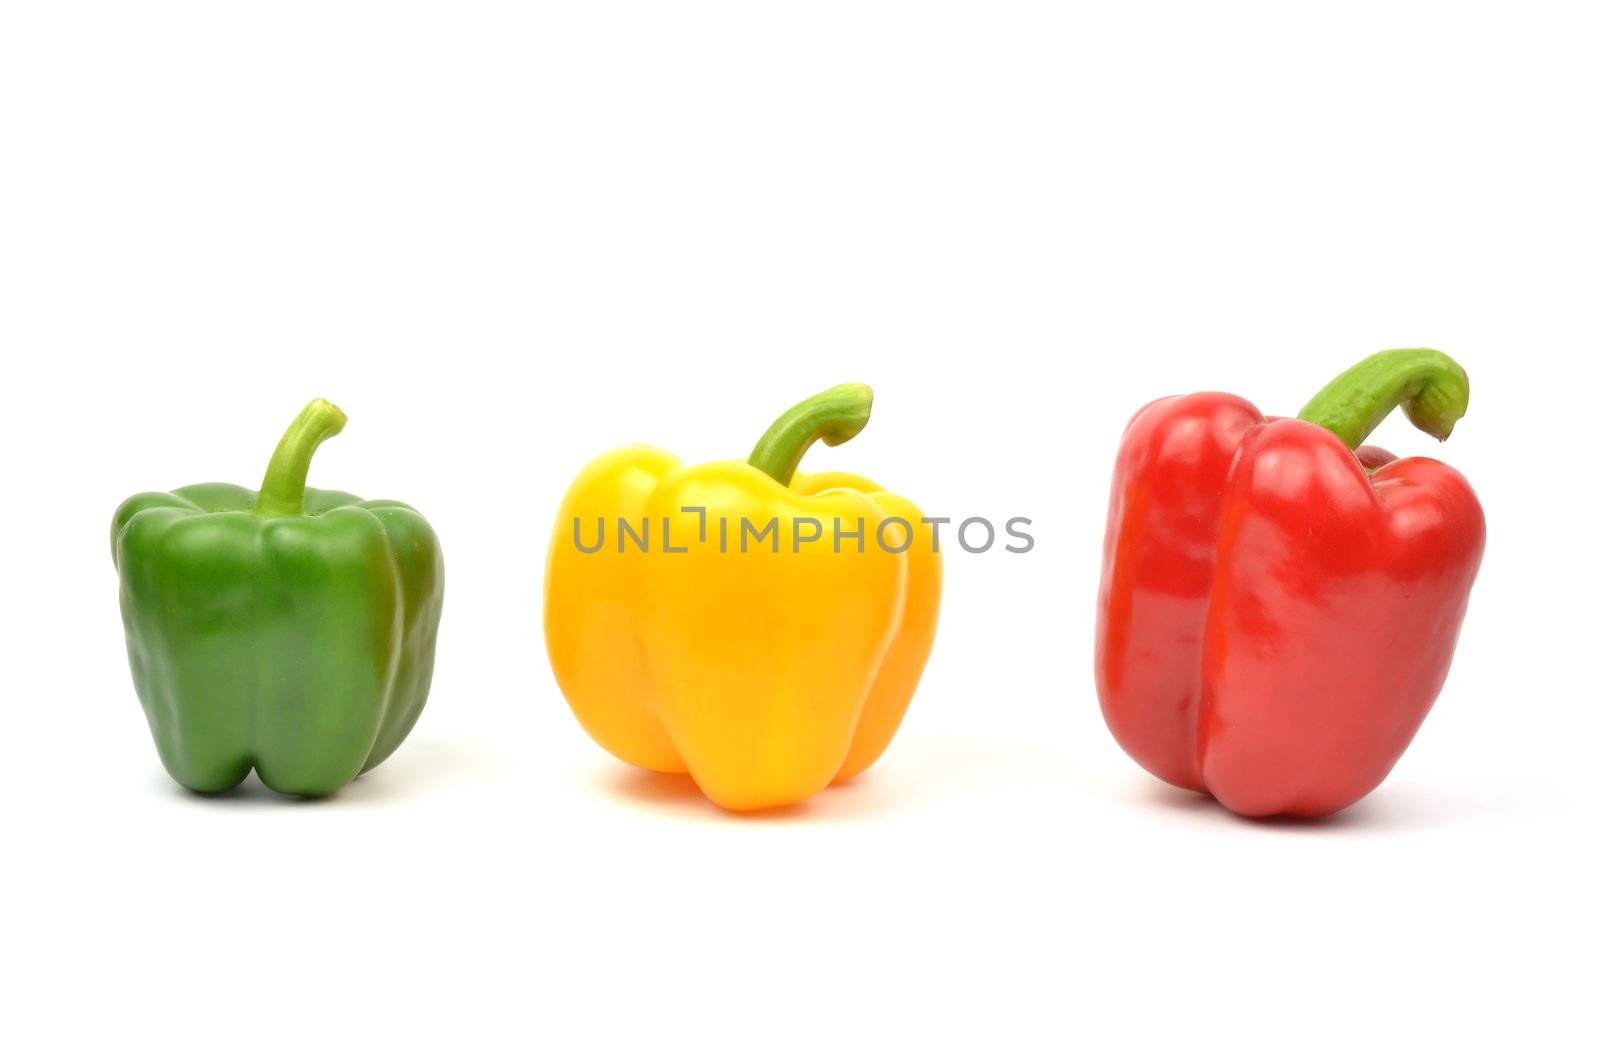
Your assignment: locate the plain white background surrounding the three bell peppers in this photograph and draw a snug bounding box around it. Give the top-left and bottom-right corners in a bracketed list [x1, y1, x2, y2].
[0, 0, 1600, 1057]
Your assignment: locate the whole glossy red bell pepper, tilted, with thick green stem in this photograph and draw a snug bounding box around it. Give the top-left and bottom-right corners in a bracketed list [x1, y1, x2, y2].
[1094, 349, 1485, 817]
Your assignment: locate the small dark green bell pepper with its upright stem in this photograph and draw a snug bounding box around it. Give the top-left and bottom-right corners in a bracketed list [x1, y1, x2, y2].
[110, 400, 445, 796]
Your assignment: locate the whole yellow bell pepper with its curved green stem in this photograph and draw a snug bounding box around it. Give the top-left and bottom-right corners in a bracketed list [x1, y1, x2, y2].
[544, 384, 941, 810]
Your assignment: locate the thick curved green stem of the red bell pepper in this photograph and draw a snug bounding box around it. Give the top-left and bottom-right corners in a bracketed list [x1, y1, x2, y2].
[1299, 349, 1469, 448]
